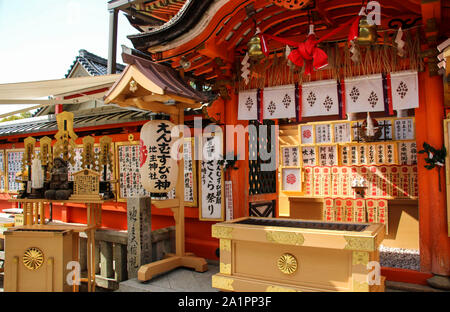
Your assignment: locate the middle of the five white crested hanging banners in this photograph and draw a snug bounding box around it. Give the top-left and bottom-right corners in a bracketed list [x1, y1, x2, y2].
[302, 80, 339, 117]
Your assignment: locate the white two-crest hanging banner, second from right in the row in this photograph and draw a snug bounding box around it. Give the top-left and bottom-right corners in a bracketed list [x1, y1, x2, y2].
[345, 74, 384, 113]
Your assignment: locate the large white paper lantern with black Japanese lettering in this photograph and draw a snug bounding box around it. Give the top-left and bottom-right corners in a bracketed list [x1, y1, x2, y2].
[139, 115, 178, 194]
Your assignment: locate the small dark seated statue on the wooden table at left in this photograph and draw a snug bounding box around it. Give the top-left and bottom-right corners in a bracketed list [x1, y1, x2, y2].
[45, 157, 72, 200]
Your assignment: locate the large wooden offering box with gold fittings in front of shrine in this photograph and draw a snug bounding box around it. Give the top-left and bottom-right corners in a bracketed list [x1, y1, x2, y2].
[212, 217, 385, 292]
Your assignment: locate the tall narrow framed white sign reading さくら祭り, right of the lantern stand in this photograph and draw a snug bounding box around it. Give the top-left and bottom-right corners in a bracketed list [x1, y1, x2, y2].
[199, 133, 225, 221]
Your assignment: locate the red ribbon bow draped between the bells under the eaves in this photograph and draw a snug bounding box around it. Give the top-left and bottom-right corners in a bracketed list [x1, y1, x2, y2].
[259, 15, 361, 75]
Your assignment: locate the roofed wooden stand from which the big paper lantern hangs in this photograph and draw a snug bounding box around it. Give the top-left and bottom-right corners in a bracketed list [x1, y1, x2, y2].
[104, 54, 208, 281]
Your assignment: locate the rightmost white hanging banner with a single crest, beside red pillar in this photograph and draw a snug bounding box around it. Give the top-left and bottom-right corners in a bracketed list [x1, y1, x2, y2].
[391, 70, 419, 110]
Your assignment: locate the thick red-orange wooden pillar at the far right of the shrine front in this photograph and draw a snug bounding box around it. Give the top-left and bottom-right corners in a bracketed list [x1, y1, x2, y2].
[416, 67, 450, 276]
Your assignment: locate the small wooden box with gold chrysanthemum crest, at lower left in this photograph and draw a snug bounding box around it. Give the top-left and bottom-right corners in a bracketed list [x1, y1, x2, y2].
[4, 227, 78, 292]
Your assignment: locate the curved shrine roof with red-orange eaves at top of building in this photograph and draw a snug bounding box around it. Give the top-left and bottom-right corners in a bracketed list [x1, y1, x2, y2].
[118, 0, 422, 80]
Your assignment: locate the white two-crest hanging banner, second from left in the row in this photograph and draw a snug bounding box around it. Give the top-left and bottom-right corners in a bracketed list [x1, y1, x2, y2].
[263, 85, 296, 119]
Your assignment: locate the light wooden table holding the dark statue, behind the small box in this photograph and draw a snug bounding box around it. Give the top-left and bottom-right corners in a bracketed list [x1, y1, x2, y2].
[8, 199, 108, 292]
